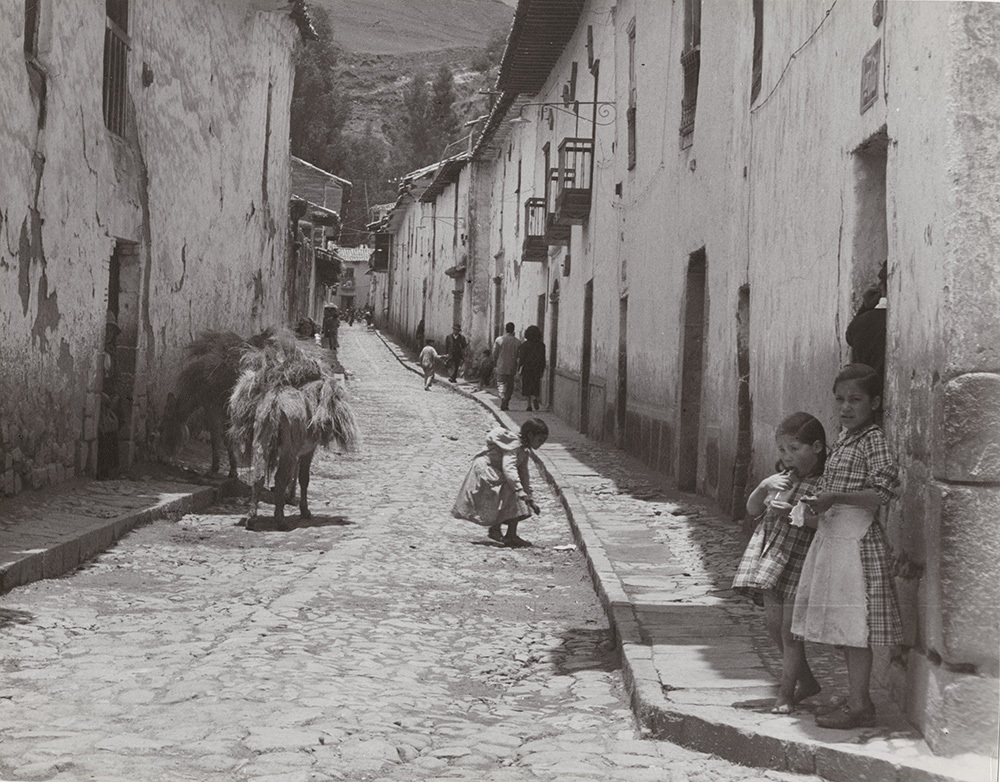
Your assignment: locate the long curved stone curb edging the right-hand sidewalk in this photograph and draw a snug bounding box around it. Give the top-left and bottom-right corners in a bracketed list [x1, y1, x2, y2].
[375, 329, 986, 782]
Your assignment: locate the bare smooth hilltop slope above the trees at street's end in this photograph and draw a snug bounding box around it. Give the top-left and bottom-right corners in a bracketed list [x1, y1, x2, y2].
[311, 0, 514, 54]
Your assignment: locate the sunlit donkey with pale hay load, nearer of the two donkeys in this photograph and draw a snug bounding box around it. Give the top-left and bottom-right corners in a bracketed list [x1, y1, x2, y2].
[229, 330, 358, 529]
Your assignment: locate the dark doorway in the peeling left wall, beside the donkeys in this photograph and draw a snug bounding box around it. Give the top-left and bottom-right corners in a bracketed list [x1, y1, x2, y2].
[95, 240, 141, 478]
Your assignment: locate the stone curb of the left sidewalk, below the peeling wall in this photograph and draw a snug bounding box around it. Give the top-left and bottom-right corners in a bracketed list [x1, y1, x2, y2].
[0, 486, 220, 594]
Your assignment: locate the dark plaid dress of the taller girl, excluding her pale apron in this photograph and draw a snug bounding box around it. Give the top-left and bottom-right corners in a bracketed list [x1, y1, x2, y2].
[793, 424, 903, 646]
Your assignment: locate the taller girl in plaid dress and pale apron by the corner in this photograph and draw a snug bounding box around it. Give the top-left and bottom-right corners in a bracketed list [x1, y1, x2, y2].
[792, 364, 903, 728]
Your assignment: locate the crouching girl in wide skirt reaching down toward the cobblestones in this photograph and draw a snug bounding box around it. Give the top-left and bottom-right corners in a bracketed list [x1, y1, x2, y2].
[451, 418, 549, 548]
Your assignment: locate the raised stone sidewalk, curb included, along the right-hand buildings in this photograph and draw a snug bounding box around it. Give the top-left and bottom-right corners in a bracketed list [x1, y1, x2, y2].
[376, 331, 997, 782]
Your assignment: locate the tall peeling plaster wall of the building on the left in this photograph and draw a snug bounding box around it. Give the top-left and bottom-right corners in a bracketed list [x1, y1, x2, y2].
[0, 0, 298, 494]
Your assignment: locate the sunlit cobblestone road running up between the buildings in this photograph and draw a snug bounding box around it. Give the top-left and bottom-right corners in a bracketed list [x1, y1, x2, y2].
[0, 327, 820, 782]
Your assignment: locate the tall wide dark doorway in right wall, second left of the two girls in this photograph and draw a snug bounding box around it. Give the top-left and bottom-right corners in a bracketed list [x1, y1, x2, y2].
[677, 247, 708, 491]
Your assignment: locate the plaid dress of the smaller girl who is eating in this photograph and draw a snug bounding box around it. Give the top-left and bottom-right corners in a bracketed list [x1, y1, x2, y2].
[733, 476, 820, 603]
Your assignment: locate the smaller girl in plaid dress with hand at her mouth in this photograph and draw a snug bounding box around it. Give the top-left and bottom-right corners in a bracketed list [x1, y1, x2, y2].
[733, 413, 826, 714]
